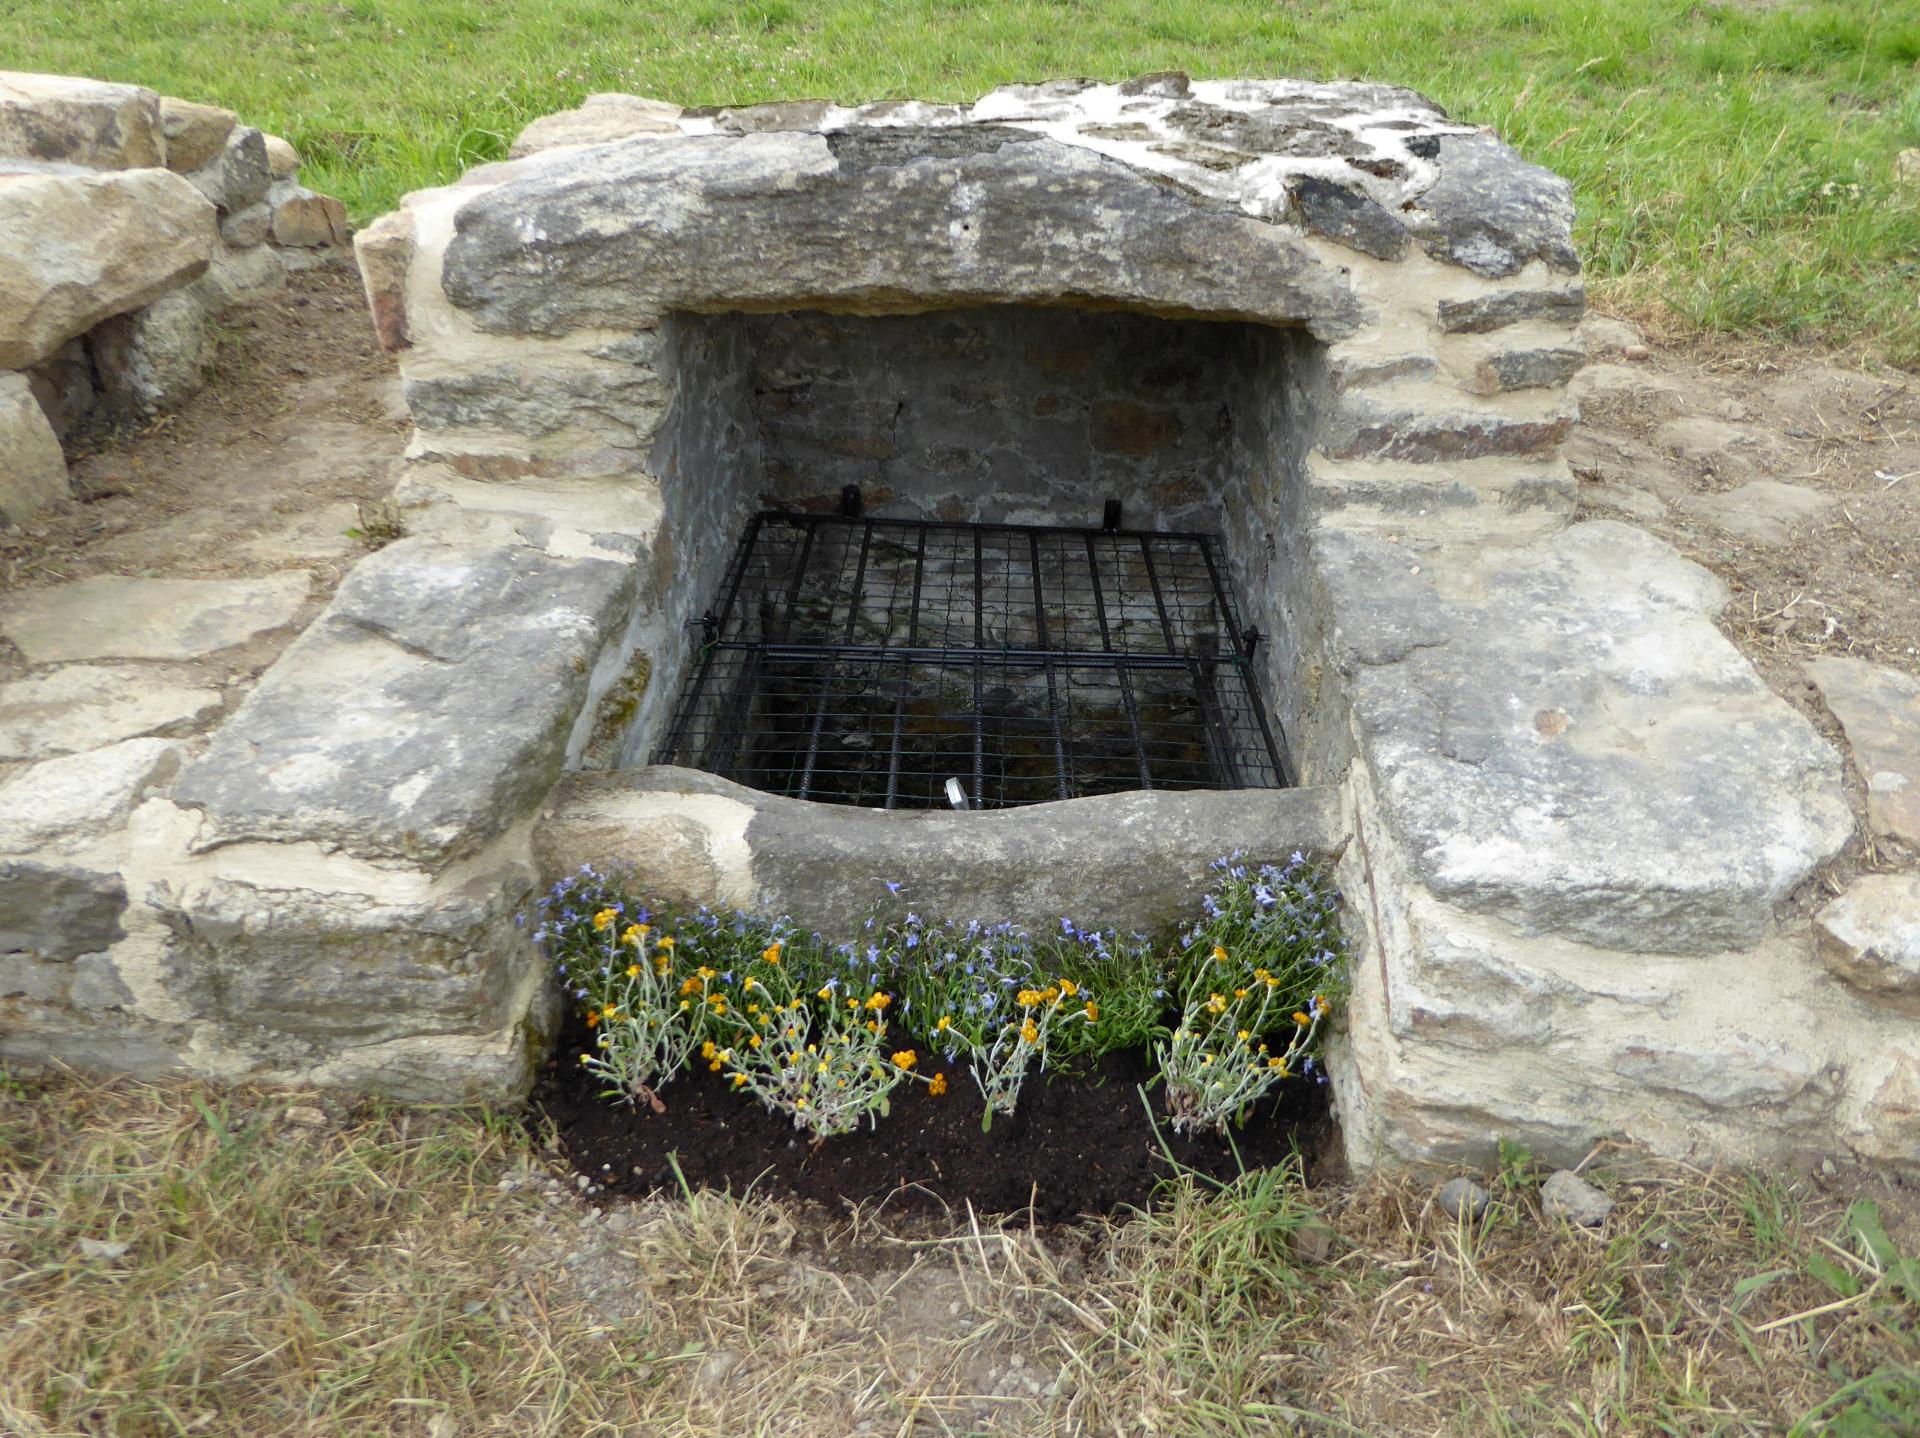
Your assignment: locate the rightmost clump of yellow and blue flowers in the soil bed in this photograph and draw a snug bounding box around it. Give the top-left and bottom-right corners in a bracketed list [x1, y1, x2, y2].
[1156, 854, 1346, 1131]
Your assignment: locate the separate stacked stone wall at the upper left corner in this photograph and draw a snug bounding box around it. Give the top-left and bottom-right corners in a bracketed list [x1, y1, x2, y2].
[0, 71, 348, 524]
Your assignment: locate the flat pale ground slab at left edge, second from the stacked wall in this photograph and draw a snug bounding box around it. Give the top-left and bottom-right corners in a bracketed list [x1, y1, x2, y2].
[0, 664, 221, 758]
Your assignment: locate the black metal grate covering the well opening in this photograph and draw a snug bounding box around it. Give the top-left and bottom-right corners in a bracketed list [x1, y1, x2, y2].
[655, 513, 1288, 808]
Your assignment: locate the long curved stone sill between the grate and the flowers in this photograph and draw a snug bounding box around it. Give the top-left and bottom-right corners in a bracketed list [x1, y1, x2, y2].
[534, 764, 1346, 933]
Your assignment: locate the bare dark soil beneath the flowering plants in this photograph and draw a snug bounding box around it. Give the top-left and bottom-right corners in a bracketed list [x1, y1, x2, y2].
[534, 1006, 1344, 1223]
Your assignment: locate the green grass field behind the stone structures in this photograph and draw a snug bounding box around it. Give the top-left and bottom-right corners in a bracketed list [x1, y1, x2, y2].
[0, 0, 1920, 367]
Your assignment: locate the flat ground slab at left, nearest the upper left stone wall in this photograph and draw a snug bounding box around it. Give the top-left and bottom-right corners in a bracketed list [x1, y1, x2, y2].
[0, 570, 311, 664]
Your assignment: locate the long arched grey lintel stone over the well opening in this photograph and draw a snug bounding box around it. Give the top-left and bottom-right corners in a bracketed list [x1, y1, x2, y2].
[442, 125, 1361, 338]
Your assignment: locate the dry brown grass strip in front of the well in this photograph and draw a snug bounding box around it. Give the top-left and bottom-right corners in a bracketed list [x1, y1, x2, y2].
[0, 1075, 1920, 1438]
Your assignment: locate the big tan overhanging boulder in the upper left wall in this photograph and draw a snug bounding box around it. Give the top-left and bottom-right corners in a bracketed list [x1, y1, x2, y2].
[0, 169, 215, 369]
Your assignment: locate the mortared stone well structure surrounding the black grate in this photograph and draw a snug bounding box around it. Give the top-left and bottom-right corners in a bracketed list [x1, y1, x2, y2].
[6, 75, 1920, 1163]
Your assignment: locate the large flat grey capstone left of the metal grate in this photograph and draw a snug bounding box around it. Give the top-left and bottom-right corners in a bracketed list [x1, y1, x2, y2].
[175, 538, 634, 864]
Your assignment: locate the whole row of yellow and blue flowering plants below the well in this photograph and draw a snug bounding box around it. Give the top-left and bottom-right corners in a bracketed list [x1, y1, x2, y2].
[536, 854, 1346, 1138]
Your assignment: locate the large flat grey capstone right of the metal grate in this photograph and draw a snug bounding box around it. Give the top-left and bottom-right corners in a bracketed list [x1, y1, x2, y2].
[1313, 520, 1853, 954]
